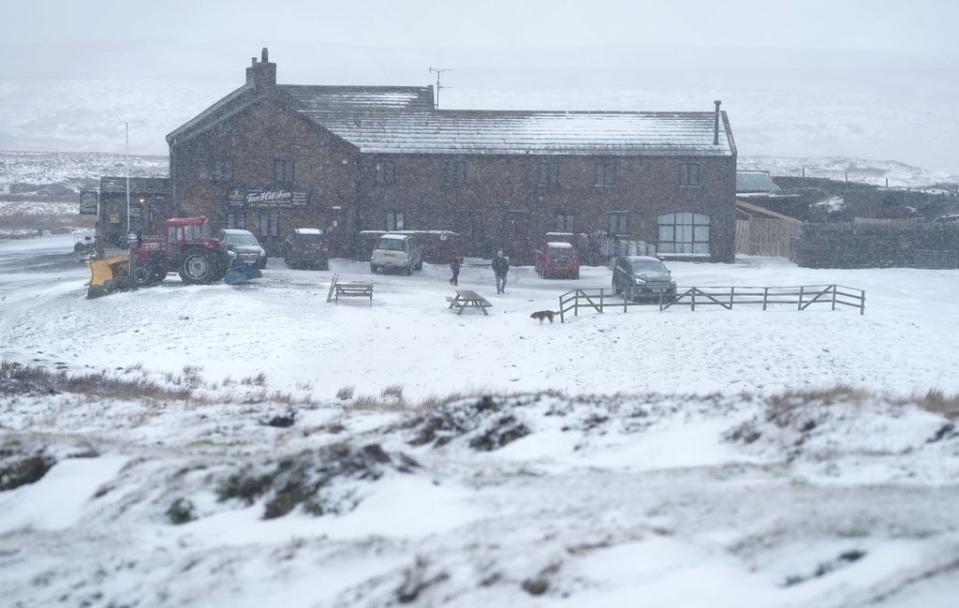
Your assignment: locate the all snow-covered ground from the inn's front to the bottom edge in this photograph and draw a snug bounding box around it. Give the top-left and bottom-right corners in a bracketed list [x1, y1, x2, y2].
[0, 236, 959, 608]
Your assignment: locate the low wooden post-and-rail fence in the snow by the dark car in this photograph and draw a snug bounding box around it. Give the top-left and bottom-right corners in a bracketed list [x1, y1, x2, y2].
[559, 285, 866, 323]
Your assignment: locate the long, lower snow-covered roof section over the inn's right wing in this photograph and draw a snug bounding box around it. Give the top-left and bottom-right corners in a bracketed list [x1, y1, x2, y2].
[294, 108, 735, 156]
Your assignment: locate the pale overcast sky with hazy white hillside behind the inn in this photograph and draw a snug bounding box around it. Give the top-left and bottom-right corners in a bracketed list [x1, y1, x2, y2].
[0, 0, 959, 172]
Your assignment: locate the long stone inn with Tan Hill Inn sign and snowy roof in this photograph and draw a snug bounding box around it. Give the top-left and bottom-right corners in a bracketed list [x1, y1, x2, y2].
[167, 49, 736, 262]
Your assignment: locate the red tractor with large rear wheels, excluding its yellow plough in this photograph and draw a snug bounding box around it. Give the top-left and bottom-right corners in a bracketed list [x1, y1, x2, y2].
[130, 217, 230, 285]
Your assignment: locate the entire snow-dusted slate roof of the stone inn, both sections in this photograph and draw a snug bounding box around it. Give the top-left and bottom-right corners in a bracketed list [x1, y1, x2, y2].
[167, 85, 736, 156]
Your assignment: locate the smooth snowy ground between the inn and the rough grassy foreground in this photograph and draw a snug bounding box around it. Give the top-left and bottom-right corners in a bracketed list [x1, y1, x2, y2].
[0, 235, 959, 399]
